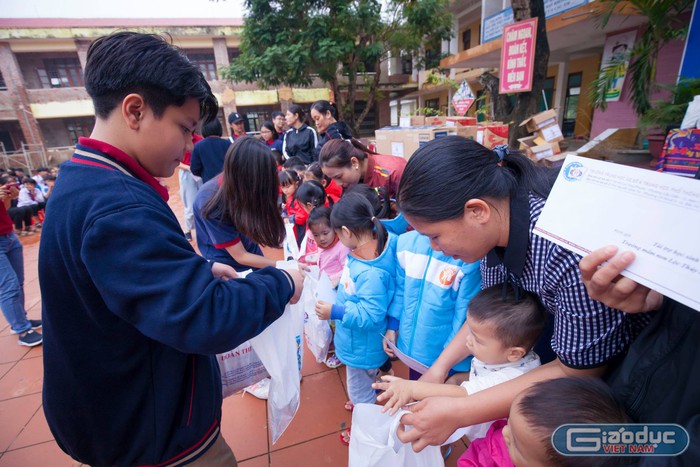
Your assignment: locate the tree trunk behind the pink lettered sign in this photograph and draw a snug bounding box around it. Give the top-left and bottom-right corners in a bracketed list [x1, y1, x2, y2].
[508, 0, 549, 146]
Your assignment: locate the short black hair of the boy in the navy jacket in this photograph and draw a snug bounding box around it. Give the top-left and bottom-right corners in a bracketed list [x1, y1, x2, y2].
[85, 31, 219, 125]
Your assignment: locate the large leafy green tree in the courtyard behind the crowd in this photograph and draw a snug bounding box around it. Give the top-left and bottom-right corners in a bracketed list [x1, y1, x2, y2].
[223, 0, 453, 133]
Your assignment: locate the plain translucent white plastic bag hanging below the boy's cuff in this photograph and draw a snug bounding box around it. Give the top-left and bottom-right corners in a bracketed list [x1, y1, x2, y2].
[250, 305, 304, 444]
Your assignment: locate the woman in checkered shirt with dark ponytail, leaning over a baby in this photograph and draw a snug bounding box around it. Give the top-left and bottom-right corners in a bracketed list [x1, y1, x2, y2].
[388, 136, 648, 450]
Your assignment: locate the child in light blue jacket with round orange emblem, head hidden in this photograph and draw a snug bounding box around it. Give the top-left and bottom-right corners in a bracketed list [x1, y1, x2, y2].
[385, 231, 481, 380]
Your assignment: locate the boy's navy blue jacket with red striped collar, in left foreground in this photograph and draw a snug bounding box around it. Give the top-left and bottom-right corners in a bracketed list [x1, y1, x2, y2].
[39, 138, 293, 466]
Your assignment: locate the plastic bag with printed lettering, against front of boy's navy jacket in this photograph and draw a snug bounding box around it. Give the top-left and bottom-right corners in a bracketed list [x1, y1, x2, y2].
[216, 341, 269, 397]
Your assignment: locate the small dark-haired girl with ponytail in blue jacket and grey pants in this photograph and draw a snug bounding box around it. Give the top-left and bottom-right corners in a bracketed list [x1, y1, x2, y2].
[316, 193, 396, 442]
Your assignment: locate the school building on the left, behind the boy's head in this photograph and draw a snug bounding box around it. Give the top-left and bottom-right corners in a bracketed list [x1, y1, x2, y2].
[0, 18, 417, 166]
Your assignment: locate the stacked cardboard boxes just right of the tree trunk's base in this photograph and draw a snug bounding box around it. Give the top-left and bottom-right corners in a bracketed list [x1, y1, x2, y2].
[518, 109, 565, 166]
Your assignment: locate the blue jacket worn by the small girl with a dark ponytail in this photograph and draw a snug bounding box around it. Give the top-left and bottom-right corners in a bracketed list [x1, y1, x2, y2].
[331, 233, 396, 370]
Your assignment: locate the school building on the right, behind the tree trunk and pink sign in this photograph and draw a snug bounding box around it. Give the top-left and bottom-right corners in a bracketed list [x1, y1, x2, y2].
[390, 0, 690, 139]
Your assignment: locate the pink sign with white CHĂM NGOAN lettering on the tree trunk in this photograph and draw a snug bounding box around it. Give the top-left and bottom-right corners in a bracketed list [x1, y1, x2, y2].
[499, 18, 537, 94]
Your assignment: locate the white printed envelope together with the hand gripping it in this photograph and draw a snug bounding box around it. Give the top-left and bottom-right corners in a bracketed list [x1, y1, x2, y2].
[534, 156, 700, 312]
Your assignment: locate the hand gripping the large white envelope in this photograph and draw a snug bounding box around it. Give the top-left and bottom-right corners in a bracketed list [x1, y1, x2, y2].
[579, 245, 663, 313]
